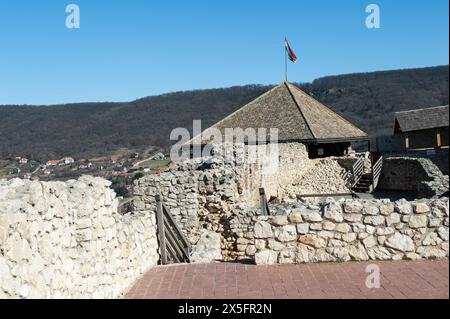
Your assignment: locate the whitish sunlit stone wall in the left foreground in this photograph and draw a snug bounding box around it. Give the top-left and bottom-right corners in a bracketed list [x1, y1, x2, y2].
[0, 176, 159, 298]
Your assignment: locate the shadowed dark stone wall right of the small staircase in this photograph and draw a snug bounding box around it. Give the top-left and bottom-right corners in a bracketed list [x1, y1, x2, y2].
[378, 157, 449, 198]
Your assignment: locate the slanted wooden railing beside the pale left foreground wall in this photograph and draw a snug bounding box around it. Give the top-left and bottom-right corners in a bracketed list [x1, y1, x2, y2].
[156, 195, 190, 265]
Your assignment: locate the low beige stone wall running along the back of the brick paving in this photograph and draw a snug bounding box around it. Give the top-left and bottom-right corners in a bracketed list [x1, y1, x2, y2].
[227, 198, 449, 264]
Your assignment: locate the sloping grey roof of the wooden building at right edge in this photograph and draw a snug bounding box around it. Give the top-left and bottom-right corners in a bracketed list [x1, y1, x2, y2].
[395, 105, 449, 133]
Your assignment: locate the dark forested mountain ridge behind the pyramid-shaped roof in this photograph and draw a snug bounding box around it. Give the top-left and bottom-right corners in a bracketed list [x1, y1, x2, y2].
[0, 65, 449, 160]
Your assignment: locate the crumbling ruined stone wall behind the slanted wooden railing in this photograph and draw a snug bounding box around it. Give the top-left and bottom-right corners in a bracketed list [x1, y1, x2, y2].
[130, 143, 312, 260]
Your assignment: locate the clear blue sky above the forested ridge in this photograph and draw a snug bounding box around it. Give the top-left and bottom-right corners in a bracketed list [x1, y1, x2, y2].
[0, 0, 449, 104]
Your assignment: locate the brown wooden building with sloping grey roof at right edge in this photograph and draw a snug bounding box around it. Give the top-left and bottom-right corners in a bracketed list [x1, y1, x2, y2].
[394, 105, 449, 151]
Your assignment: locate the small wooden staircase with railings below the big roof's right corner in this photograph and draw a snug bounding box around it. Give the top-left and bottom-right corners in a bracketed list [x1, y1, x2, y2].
[352, 152, 383, 193]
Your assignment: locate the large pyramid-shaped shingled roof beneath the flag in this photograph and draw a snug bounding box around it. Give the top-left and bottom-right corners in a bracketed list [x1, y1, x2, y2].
[193, 82, 367, 144]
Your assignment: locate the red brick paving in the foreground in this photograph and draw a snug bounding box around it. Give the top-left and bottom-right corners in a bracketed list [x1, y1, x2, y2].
[125, 259, 449, 299]
